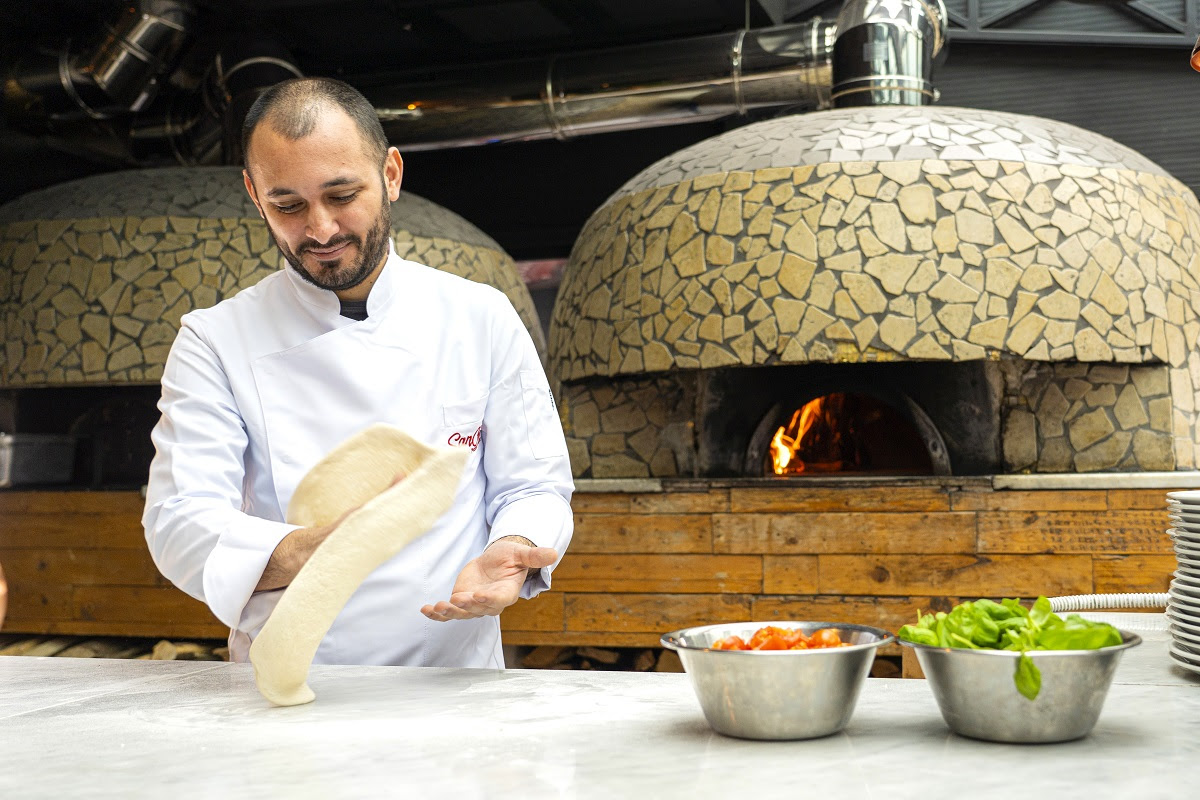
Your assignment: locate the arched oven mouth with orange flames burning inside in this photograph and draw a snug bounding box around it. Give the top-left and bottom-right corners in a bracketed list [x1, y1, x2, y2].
[763, 392, 936, 476]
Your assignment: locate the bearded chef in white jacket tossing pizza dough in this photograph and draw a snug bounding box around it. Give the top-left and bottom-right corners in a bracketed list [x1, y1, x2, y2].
[143, 78, 574, 668]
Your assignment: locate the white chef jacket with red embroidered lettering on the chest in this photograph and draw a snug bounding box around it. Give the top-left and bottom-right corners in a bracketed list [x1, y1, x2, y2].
[143, 252, 574, 668]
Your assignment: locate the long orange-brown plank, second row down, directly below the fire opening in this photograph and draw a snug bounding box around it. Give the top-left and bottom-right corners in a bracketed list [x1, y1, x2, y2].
[713, 512, 976, 554]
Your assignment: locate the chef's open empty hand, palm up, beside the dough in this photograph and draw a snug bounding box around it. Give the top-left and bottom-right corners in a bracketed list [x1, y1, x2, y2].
[421, 536, 558, 622]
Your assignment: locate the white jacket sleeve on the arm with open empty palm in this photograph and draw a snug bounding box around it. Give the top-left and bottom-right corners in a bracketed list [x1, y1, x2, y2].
[484, 291, 575, 599]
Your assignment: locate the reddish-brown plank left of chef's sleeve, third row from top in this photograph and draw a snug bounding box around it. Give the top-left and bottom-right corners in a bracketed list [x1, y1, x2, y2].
[0, 548, 169, 587]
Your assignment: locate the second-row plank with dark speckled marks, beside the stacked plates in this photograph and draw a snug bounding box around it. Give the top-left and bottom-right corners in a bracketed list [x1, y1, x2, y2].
[978, 510, 1171, 553]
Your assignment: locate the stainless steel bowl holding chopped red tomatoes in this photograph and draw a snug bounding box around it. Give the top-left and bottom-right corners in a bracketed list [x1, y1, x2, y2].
[661, 621, 894, 739]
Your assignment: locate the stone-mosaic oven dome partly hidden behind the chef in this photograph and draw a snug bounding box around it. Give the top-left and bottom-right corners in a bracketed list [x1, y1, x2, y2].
[0, 168, 544, 387]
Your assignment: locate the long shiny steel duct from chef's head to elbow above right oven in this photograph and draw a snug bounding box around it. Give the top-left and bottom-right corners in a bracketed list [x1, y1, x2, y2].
[352, 0, 947, 150]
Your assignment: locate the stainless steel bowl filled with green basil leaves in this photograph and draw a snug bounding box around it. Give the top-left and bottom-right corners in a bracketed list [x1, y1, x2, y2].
[900, 631, 1141, 742]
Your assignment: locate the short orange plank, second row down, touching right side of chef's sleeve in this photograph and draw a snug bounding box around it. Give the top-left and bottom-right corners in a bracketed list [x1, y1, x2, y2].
[570, 513, 713, 553]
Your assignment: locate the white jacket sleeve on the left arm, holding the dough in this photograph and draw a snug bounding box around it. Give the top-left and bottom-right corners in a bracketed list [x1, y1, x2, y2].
[142, 319, 296, 628]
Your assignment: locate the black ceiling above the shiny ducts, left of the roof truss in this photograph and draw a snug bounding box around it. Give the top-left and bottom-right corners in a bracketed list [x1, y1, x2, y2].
[0, 0, 811, 76]
